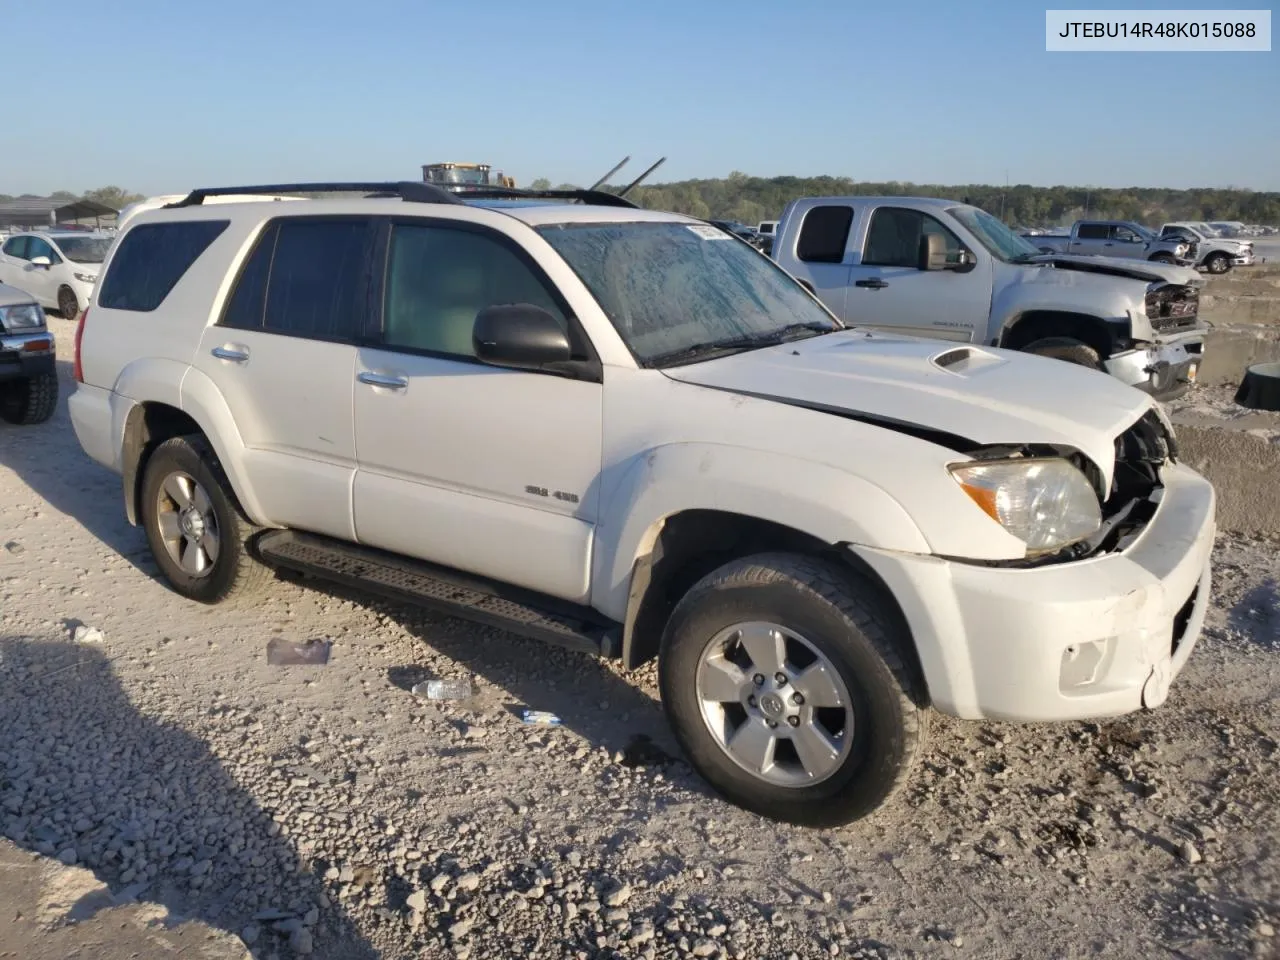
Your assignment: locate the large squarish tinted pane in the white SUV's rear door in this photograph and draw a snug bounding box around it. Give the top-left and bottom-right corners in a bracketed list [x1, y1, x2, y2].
[261, 219, 370, 339]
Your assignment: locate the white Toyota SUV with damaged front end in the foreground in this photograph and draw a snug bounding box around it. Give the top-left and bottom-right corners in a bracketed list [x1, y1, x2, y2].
[70, 183, 1215, 824]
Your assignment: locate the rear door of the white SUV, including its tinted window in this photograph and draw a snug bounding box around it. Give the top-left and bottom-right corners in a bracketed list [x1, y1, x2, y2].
[193, 216, 372, 540]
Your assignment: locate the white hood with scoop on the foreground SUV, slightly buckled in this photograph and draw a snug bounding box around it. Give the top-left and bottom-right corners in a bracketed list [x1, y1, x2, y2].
[663, 330, 1152, 489]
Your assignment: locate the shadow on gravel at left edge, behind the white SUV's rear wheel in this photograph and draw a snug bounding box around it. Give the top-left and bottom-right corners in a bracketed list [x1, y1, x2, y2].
[0, 360, 159, 577]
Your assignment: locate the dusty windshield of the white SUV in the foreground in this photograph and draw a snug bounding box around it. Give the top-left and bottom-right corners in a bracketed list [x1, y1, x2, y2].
[538, 221, 842, 366]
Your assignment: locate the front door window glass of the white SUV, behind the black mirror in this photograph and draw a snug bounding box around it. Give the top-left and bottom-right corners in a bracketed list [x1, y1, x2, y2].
[383, 224, 570, 357]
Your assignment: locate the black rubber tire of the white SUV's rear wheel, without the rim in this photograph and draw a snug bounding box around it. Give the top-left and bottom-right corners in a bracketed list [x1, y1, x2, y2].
[141, 434, 274, 604]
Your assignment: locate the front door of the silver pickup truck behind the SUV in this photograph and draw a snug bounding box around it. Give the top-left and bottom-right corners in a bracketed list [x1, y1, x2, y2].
[846, 206, 991, 342]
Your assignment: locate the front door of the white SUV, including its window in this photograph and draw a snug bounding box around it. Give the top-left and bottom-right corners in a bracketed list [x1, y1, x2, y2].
[353, 220, 602, 603]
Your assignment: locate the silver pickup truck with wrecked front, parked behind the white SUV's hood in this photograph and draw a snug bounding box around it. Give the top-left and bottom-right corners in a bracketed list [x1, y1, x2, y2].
[772, 197, 1206, 399]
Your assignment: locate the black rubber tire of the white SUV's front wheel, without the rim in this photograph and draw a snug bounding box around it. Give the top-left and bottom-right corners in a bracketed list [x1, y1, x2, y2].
[658, 553, 928, 827]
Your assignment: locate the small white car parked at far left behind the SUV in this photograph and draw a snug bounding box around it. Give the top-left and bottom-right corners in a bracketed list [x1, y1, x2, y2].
[0, 230, 111, 320]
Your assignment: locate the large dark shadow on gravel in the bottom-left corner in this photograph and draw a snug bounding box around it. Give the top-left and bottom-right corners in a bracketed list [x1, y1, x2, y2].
[0, 637, 378, 960]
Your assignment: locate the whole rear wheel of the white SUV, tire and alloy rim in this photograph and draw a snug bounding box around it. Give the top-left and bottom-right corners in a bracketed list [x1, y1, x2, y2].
[141, 435, 271, 603]
